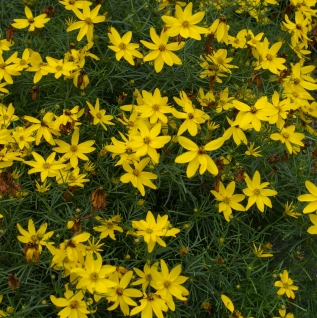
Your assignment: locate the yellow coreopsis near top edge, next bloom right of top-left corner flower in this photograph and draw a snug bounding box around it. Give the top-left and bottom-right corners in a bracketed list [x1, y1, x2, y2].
[66, 1, 106, 42]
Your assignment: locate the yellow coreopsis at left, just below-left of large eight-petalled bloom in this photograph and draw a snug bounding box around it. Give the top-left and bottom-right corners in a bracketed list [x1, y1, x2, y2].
[24, 151, 66, 182]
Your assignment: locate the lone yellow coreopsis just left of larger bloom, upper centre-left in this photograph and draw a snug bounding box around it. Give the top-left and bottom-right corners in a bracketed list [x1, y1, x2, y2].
[108, 27, 143, 65]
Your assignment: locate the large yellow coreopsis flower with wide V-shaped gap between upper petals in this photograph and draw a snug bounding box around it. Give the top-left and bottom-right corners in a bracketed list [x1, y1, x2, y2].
[175, 136, 225, 178]
